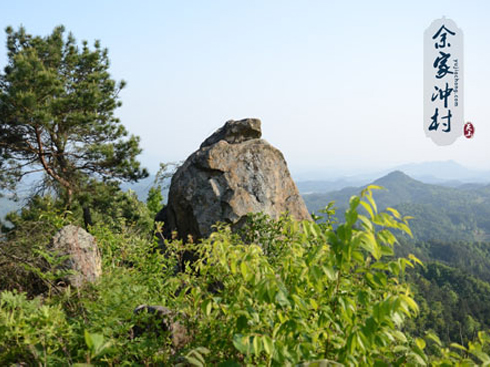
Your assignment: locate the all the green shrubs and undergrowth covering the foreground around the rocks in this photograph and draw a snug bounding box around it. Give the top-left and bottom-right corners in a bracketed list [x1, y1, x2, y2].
[0, 184, 489, 366]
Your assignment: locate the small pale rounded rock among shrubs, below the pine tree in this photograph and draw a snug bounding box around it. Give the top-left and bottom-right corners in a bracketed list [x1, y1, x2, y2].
[51, 224, 102, 287]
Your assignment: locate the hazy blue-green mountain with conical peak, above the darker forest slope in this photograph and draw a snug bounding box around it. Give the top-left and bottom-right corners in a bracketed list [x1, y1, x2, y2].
[303, 171, 490, 241]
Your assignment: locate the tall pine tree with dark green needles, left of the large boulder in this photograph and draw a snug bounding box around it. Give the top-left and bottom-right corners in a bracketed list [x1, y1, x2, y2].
[0, 27, 147, 224]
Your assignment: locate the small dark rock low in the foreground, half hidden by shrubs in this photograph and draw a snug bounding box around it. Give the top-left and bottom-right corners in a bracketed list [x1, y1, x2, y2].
[131, 305, 190, 350]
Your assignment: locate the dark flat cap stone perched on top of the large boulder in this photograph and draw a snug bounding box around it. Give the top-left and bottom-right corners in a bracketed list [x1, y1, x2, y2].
[200, 119, 262, 149]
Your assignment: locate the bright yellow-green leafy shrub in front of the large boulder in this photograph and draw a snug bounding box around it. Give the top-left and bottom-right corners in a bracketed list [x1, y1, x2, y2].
[170, 189, 425, 365]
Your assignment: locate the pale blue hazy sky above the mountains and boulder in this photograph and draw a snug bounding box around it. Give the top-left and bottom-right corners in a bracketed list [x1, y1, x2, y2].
[0, 0, 490, 178]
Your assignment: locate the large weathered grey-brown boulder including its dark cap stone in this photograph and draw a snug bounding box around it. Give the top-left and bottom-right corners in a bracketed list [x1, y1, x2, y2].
[156, 119, 311, 240]
